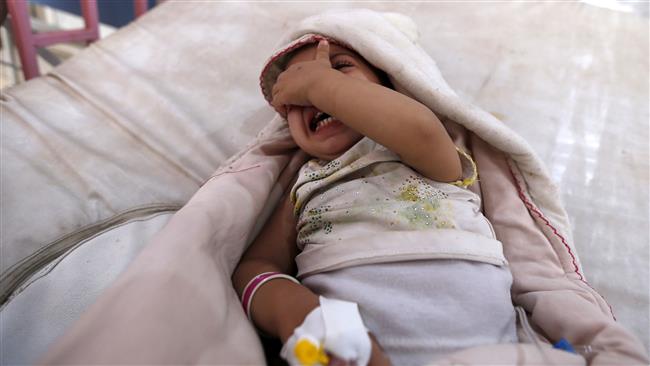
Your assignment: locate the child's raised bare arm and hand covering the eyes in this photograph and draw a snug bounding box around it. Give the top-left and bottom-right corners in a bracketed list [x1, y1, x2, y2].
[272, 41, 461, 182]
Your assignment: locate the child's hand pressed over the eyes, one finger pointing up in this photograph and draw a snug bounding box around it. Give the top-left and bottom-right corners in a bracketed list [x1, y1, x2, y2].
[271, 40, 334, 118]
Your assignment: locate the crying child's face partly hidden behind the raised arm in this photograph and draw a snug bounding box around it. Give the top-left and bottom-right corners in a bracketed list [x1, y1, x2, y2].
[287, 43, 380, 160]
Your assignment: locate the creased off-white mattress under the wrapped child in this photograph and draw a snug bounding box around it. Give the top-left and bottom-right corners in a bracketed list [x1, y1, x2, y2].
[0, 1, 650, 364]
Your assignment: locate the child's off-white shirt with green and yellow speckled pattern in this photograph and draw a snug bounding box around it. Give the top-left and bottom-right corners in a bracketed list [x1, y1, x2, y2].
[291, 138, 494, 250]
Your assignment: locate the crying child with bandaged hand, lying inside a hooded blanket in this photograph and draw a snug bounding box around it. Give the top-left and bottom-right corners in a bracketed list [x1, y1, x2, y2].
[233, 38, 517, 365]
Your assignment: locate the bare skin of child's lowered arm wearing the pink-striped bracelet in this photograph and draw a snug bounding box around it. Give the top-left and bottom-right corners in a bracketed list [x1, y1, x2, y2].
[232, 196, 390, 365]
